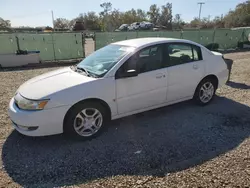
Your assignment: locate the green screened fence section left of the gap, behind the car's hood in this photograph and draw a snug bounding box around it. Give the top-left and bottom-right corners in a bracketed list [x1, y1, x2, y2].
[0, 33, 85, 61]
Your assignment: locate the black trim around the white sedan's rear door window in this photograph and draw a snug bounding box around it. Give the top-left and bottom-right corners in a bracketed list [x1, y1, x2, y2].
[164, 42, 203, 67]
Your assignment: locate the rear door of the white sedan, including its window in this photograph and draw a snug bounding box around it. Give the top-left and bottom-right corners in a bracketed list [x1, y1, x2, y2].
[165, 43, 205, 102]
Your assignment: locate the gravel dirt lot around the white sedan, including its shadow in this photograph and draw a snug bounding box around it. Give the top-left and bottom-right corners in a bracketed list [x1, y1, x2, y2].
[0, 52, 250, 188]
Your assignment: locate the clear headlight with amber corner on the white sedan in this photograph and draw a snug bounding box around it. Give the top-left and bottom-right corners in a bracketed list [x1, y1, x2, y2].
[14, 93, 49, 110]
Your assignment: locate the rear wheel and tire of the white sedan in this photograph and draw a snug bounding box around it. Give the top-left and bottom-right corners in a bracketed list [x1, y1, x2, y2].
[193, 78, 217, 106]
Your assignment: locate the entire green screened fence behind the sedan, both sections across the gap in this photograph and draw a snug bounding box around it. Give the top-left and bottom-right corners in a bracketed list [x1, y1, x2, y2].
[0, 29, 250, 61]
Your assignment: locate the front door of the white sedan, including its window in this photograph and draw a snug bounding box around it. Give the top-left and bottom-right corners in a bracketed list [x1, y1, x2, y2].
[116, 45, 167, 114]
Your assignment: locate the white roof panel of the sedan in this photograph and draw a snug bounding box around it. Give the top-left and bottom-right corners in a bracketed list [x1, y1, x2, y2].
[113, 37, 200, 48]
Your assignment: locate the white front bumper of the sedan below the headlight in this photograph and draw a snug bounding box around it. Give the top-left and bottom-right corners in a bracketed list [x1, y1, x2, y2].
[8, 98, 70, 136]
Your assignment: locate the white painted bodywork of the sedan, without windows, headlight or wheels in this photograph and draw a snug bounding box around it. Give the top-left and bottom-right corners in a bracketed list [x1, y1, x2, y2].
[9, 38, 228, 136]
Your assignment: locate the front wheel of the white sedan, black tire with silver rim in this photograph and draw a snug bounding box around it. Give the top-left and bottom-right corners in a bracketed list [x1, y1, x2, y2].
[63, 101, 108, 140]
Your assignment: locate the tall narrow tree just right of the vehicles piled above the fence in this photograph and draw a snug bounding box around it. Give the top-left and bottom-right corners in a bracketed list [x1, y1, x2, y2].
[159, 3, 173, 30]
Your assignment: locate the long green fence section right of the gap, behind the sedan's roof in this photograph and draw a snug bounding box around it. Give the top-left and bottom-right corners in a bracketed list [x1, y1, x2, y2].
[95, 29, 249, 50]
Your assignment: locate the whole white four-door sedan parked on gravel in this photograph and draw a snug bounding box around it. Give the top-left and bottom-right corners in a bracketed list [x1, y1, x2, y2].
[9, 38, 229, 139]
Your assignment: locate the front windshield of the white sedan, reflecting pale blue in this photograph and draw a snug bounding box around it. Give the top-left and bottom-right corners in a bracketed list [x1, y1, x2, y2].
[77, 44, 135, 77]
